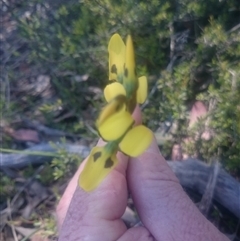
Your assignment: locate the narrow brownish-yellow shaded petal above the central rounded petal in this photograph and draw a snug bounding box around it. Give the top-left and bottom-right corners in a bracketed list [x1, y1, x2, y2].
[96, 95, 126, 126]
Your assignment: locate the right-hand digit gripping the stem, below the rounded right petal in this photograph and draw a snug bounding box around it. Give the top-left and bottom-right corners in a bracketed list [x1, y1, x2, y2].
[127, 137, 227, 241]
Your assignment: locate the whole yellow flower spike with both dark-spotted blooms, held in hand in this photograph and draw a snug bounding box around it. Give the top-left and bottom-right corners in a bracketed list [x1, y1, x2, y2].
[79, 34, 153, 191]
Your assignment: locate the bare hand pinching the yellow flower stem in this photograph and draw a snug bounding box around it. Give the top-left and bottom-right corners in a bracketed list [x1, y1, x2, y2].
[57, 108, 229, 241]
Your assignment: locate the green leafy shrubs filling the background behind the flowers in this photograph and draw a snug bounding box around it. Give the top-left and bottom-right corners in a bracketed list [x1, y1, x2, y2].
[9, 0, 240, 171]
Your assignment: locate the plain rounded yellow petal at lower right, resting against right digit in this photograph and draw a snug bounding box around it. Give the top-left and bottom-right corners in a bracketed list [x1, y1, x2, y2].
[119, 125, 153, 157]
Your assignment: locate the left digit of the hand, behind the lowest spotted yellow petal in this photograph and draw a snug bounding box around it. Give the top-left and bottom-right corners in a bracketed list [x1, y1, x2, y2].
[59, 153, 128, 241]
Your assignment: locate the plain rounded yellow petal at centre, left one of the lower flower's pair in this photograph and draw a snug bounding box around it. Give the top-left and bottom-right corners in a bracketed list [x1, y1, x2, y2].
[97, 111, 134, 141]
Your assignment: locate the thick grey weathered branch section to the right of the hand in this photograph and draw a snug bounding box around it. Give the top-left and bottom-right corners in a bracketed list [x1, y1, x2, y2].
[168, 159, 240, 218]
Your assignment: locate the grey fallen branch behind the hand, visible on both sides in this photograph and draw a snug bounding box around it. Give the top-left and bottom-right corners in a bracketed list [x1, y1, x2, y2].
[0, 144, 240, 218]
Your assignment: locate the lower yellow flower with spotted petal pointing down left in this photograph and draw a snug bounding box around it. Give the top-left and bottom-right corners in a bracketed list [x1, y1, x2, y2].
[79, 96, 153, 191]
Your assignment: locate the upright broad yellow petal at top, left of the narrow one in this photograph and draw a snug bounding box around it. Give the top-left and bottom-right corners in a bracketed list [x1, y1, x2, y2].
[108, 34, 126, 82]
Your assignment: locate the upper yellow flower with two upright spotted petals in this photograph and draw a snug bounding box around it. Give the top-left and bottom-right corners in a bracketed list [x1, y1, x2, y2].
[104, 34, 147, 104]
